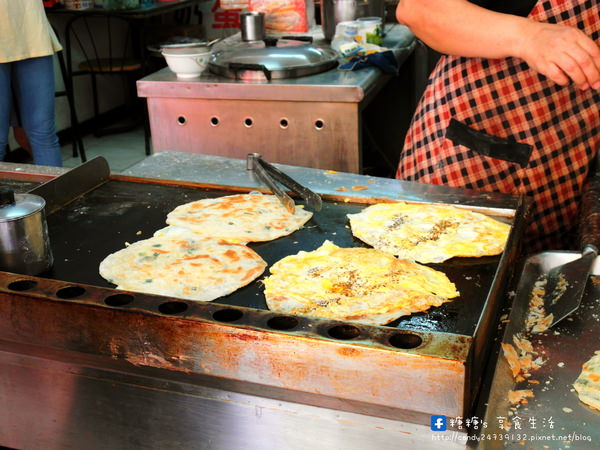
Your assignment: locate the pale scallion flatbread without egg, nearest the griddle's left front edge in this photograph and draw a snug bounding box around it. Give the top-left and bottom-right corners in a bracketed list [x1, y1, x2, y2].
[100, 227, 267, 301]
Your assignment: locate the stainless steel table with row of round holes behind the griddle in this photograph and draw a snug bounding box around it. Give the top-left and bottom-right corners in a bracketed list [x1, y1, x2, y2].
[138, 25, 416, 173]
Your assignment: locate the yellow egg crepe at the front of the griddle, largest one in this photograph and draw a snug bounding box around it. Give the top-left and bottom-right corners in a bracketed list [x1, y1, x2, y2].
[264, 241, 459, 325]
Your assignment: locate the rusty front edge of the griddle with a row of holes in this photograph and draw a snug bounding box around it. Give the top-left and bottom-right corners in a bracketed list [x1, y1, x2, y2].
[0, 273, 471, 422]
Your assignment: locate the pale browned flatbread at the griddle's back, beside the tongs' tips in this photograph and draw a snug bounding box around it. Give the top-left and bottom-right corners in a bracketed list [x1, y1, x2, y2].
[167, 194, 312, 242]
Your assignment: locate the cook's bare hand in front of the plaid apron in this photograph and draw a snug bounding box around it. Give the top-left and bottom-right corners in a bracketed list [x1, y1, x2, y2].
[519, 22, 600, 90]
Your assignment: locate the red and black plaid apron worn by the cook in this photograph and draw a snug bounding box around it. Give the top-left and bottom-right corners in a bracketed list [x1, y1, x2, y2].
[396, 0, 600, 250]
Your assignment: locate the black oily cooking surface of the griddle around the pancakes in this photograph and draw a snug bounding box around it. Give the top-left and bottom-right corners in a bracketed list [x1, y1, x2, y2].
[45, 180, 500, 336]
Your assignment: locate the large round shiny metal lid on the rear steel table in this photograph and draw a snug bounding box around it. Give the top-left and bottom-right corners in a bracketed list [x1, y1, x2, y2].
[209, 39, 337, 78]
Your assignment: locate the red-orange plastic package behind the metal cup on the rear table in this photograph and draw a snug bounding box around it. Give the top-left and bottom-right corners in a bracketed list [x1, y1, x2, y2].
[249, 0, 315, 33]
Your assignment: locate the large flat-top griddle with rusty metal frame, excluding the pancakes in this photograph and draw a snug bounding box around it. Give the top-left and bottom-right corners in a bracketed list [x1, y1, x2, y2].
[0, 157, 527, 429]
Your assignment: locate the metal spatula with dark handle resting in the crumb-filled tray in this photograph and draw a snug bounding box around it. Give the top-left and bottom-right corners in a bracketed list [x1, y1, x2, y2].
[544, 161, 600, 327]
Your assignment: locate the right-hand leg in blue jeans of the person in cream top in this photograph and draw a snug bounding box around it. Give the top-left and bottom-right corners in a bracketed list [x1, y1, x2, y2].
[13, 56, 62, 167]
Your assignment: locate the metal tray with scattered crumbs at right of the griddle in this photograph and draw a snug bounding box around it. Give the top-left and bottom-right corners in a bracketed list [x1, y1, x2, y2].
[479, 252, 600, 449]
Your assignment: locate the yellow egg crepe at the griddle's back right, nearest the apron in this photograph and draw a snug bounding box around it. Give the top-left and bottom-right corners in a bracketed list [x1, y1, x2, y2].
[348, 202, 510, 264]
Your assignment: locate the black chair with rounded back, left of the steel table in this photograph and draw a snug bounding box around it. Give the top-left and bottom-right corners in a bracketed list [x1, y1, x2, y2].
[65, 12, 150, 155]
